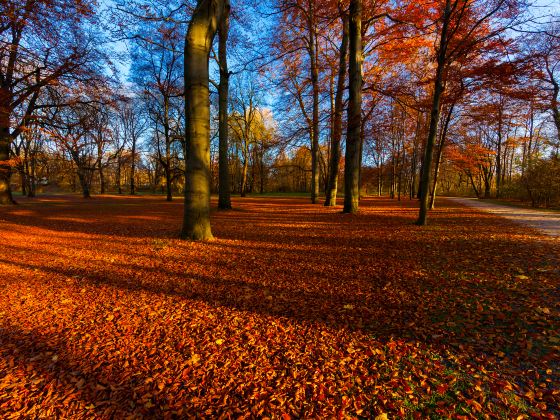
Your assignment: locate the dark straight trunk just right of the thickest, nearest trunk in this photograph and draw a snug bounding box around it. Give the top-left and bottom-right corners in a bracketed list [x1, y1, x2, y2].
[218, 5, 231, 210]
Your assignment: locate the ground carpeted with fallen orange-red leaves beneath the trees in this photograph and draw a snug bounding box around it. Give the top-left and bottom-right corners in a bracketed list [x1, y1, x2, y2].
[0, 196, 560, 419]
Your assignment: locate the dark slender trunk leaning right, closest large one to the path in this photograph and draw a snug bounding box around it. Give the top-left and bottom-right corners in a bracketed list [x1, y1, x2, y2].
[416, 0, 451, 226]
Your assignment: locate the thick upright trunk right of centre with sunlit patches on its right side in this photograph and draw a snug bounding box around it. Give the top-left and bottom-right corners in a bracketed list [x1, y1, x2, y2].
[344, 0, 363, 213]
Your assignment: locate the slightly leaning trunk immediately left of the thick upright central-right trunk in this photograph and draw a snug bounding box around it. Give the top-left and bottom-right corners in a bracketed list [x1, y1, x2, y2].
[325, 14, 349, 206]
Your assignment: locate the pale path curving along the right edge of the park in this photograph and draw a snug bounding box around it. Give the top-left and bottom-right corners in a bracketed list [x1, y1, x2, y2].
[445, 197, 560, 237]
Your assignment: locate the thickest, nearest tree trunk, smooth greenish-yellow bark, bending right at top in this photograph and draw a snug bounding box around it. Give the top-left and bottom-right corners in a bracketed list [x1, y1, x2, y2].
[181, 0, 229, 241]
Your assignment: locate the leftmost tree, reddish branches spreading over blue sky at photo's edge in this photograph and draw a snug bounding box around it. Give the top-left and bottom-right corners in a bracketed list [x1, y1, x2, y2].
[0, 0, 101, 204]
